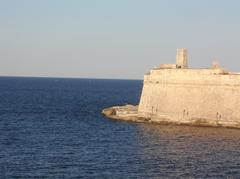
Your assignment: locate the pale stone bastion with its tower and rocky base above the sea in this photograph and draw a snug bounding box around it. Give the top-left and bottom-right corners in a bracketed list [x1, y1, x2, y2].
[102, 49, 240, 128]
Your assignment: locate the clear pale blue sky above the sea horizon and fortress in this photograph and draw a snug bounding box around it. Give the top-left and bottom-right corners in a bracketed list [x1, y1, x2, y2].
[0, 0, 240, 79]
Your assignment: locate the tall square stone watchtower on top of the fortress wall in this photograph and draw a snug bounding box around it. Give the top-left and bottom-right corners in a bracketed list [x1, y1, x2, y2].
[176, 49, 188, 68]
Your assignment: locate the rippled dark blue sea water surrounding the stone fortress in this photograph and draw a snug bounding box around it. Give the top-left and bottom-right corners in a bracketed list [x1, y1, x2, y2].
[0, 77, 240, 179]
